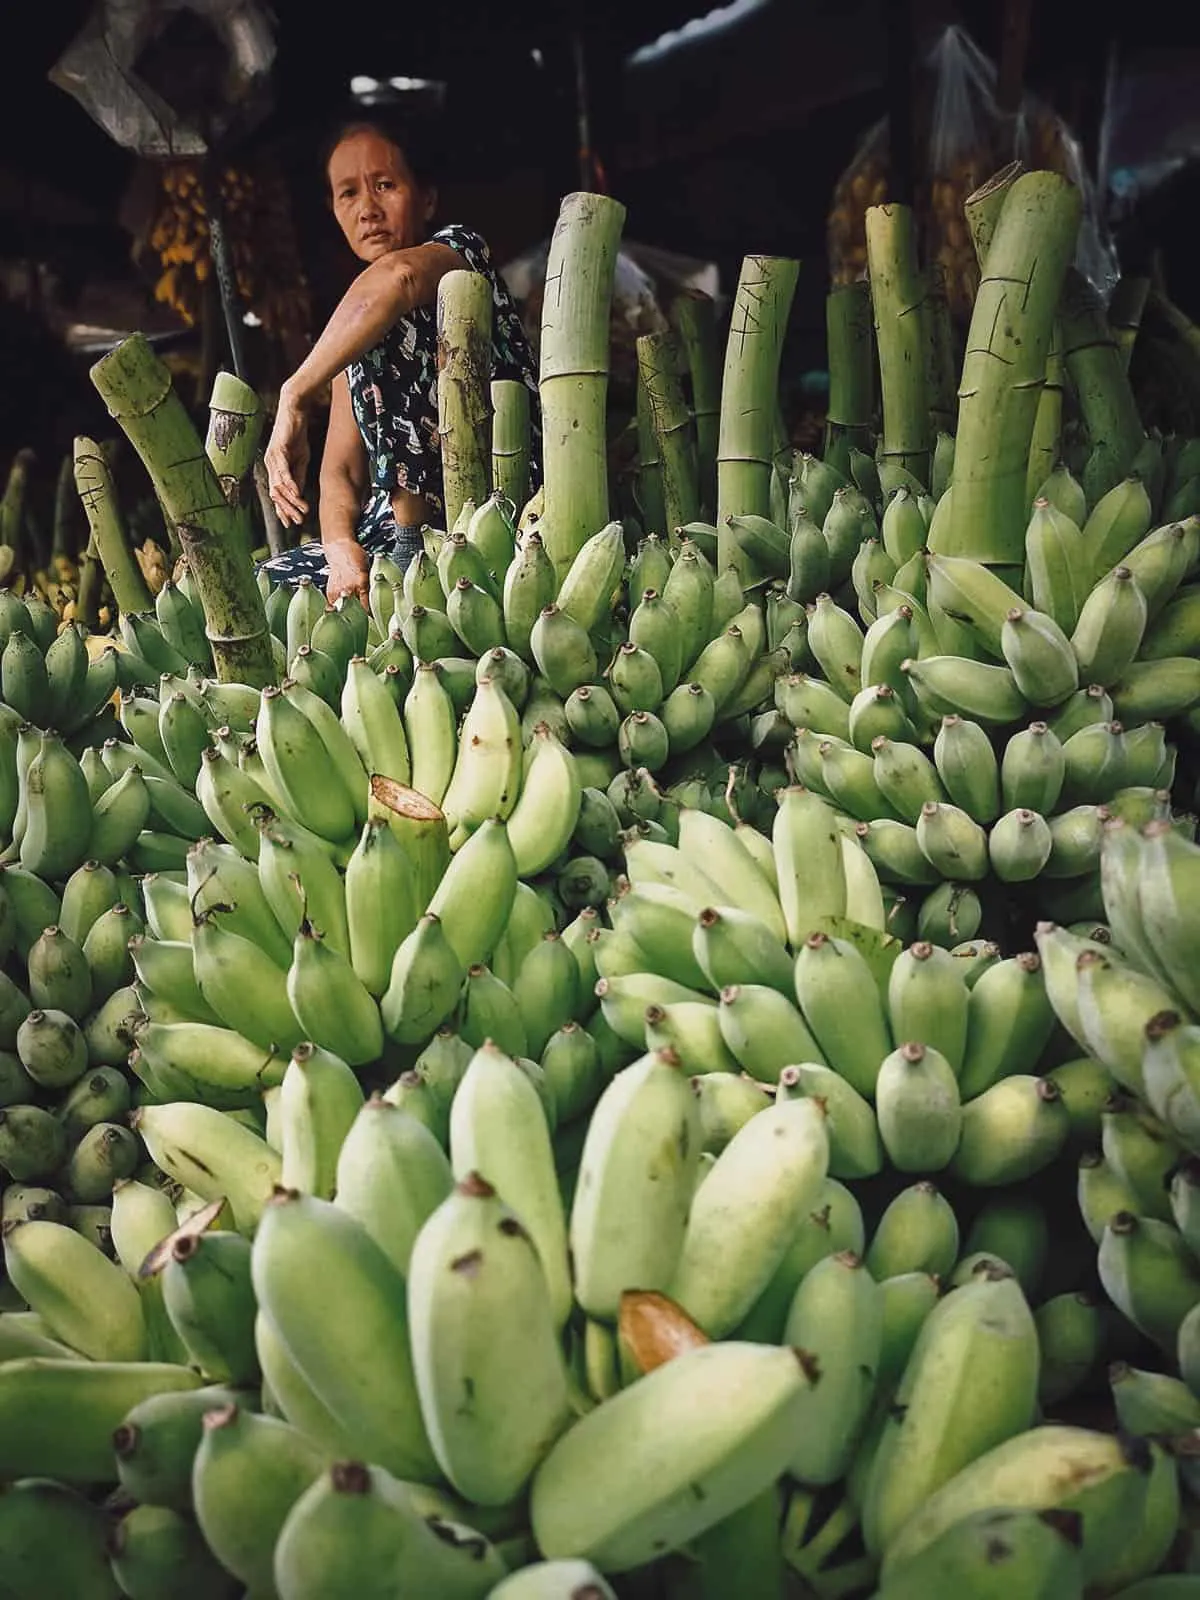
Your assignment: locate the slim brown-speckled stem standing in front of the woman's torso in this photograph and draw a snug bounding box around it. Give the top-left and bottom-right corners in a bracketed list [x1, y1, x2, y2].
[437, 270, 491, 528]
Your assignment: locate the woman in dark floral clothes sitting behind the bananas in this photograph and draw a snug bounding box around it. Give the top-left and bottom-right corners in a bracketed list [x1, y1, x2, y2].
[264, 118, 538, 605]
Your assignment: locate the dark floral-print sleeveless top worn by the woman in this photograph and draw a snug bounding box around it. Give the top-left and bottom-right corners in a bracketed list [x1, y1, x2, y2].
[346, 222, 541, 524]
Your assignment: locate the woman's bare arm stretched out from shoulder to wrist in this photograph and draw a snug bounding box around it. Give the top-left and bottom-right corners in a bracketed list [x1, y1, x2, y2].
[280, 242, 462, 408]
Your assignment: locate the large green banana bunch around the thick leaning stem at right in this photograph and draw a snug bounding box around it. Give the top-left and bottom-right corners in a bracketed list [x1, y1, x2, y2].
[733, 444, 1200, 946]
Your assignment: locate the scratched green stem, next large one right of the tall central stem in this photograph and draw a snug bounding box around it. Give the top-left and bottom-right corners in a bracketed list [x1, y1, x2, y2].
[717, 256, 800, 582]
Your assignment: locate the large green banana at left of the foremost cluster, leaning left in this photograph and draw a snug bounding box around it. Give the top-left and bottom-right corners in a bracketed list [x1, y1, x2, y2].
[251, 1189, 437, 1482]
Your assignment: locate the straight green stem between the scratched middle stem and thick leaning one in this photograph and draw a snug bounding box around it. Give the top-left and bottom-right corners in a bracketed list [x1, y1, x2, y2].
[867, 205, 933, 486]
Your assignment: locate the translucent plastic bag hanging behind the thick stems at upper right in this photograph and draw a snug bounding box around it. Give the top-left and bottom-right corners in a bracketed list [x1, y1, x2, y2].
[827, 24, 1117, 322]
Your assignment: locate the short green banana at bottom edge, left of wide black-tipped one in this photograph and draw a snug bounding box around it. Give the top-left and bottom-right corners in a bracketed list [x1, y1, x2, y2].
[192, 1405, 326, 1595]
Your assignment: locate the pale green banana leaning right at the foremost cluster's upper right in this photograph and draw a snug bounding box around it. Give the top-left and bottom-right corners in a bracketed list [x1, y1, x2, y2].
[667, 1099, 829, 1338]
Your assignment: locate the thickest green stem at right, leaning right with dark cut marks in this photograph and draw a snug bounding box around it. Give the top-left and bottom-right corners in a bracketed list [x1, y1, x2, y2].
[930, 171, 1080, 565]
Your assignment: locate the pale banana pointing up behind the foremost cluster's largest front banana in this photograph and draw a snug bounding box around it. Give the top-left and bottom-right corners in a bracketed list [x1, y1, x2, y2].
[450, 1045, 571, 1326]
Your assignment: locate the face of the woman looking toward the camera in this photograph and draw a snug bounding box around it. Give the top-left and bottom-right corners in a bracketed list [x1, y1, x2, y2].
[328, 131, 437, 261]
